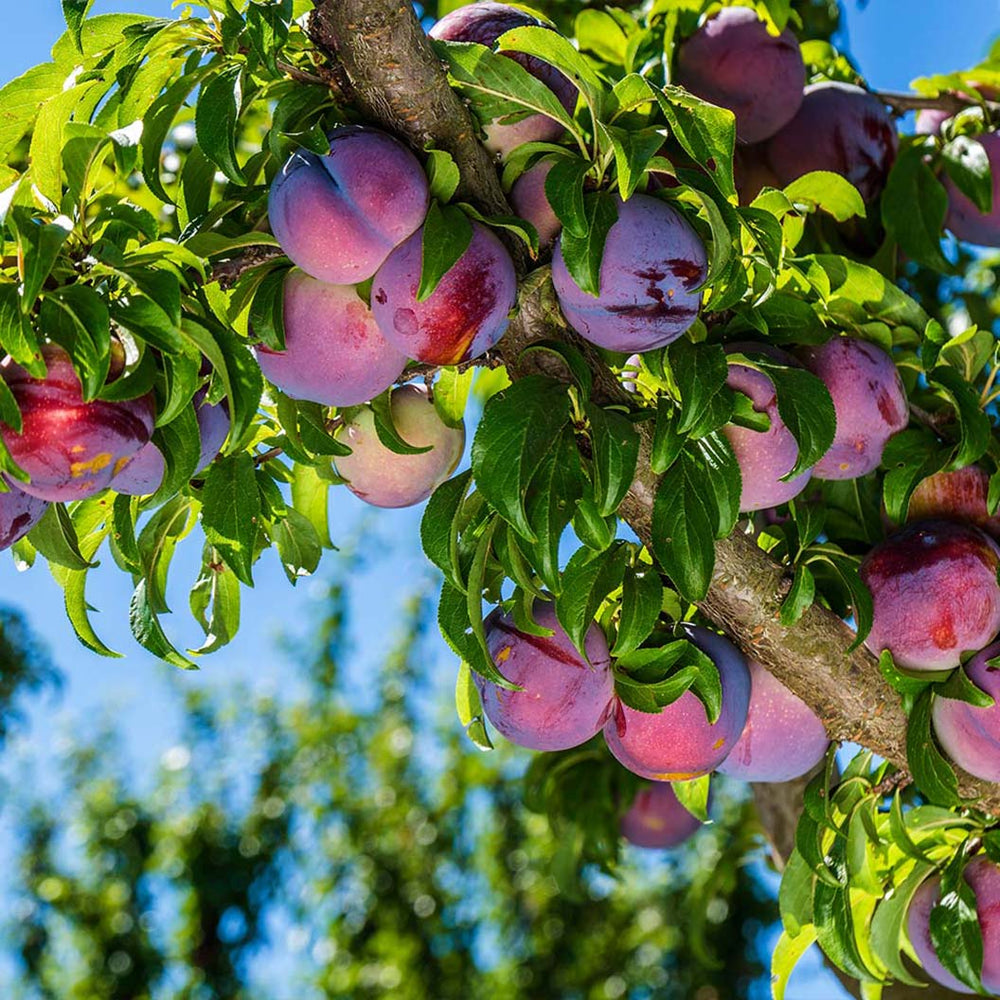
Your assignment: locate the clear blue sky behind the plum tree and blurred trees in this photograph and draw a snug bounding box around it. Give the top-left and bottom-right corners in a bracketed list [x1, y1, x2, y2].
[0, 0, 1000, 1000]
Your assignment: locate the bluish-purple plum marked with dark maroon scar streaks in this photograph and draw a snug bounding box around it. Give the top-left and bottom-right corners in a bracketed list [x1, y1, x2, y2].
[552, 194, 707, 354]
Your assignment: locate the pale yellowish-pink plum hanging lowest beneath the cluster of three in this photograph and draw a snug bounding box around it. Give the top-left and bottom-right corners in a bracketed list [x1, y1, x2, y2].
[336, 385, 465, 507]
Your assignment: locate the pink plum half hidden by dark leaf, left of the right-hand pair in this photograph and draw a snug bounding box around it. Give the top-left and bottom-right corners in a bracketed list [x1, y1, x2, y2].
[722, 352, 810, 511]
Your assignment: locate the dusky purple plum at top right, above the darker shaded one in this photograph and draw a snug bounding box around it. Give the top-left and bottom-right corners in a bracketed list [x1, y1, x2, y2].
[677, 7, 806, 142]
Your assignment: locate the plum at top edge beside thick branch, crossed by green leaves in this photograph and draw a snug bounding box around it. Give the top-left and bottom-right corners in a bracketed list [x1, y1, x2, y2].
[428, 3, 577, 157]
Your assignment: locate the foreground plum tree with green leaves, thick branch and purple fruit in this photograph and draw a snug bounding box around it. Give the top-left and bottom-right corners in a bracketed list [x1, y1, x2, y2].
[0, 0, 1000, 1000]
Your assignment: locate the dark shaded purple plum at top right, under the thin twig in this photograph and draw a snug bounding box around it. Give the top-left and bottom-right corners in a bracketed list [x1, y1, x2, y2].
[767, 82, 899, 202]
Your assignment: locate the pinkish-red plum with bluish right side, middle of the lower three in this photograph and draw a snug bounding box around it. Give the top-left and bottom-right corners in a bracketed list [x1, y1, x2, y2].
[604, 624, 750, 781]
